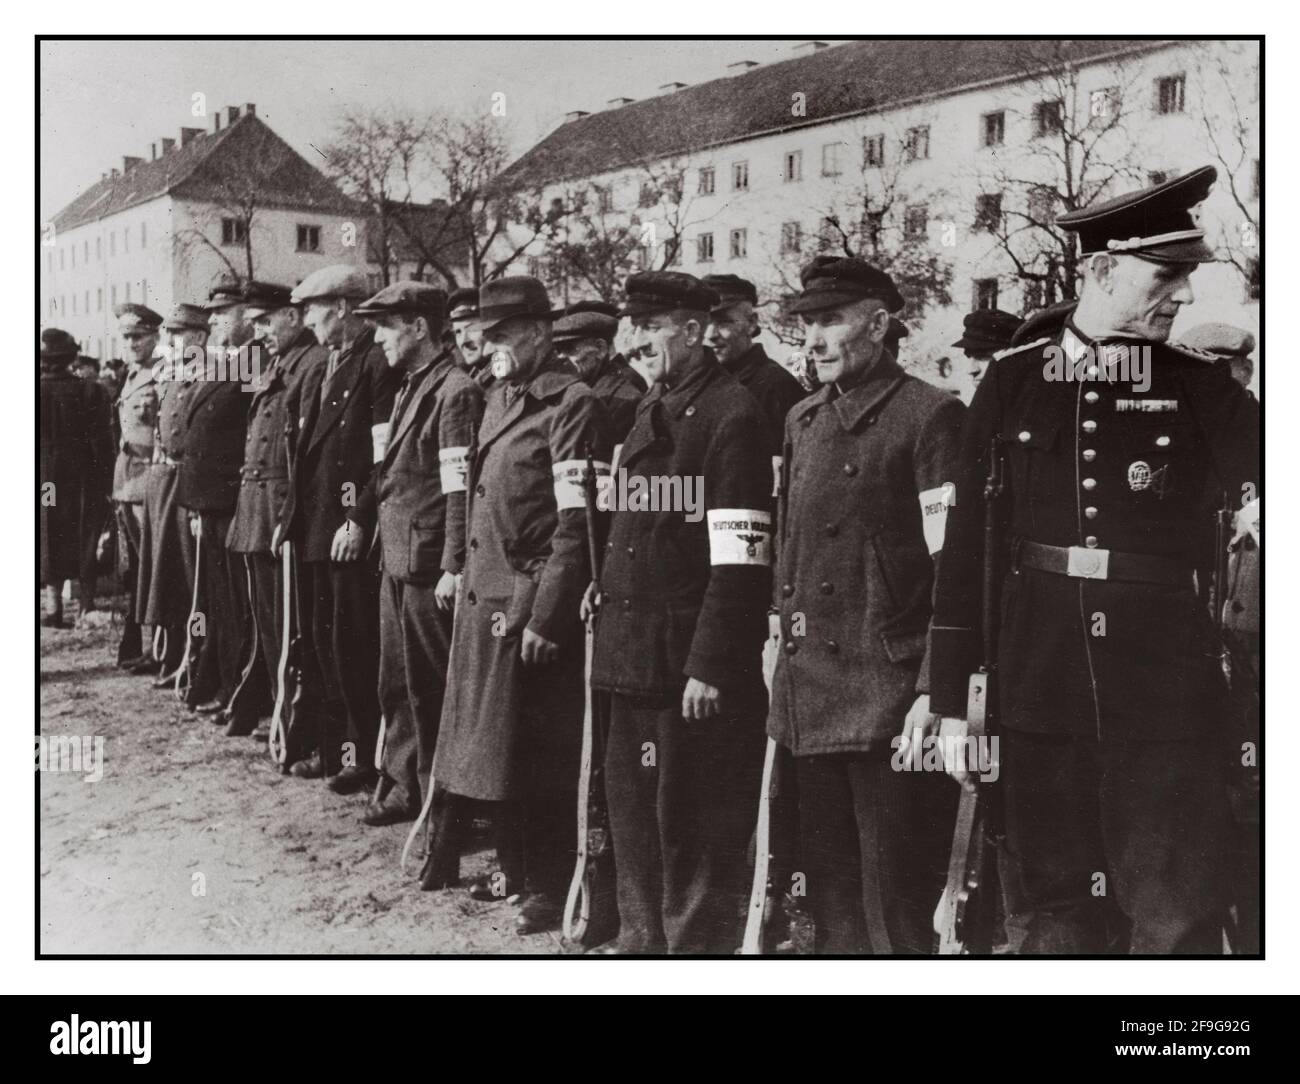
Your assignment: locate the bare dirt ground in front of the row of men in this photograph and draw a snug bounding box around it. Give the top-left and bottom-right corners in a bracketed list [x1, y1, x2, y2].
[38, 592, 564, 954]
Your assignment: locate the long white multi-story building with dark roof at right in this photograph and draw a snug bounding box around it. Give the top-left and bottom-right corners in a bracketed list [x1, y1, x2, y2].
[491, 40, 1260, 400]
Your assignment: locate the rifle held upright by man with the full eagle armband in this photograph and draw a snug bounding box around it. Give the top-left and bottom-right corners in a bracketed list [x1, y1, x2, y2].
[563, 443, 618, 945]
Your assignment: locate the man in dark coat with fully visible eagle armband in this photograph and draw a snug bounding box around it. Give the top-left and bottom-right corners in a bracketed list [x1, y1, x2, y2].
[592, 272, 772, 954]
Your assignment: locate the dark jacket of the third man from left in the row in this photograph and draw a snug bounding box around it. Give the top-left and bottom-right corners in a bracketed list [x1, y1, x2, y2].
[177, 342, 261, 515]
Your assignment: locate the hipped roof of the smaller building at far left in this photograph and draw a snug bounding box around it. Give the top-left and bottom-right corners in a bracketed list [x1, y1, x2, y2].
[53, 113, 360, 230]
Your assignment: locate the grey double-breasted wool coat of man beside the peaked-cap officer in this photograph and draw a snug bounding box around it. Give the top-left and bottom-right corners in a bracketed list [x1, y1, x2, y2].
[768, 355, 965, 756]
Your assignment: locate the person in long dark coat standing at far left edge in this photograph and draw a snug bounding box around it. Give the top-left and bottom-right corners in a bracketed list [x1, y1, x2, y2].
[39, 328, 113, 629]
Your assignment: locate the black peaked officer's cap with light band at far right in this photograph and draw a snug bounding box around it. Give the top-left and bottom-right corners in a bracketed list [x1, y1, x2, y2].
[1056, 165, 1218, 264]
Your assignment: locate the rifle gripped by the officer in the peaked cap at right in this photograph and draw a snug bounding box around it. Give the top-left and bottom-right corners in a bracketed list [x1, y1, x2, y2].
[935, 437, 1005, 955]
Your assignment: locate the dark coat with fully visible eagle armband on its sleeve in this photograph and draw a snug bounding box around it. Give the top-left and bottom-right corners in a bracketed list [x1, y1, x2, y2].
[592, 356, 772, 699]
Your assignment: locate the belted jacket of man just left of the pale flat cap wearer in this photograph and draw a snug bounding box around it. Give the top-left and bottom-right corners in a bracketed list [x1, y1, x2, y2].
[226, 328, 326, 554]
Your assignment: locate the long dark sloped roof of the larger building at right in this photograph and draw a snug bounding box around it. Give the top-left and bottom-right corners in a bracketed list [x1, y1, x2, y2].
[498, 39, 1166, 191]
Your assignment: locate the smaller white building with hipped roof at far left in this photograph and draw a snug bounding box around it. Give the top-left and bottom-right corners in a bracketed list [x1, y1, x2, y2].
[40, 104, 368, 359]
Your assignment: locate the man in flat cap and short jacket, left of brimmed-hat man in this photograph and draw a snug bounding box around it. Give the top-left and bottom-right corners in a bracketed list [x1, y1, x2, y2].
[356, 282, 484, 857]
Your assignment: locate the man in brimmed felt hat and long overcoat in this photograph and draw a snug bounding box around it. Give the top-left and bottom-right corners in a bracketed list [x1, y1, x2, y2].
[434, 276, 610, 935]
